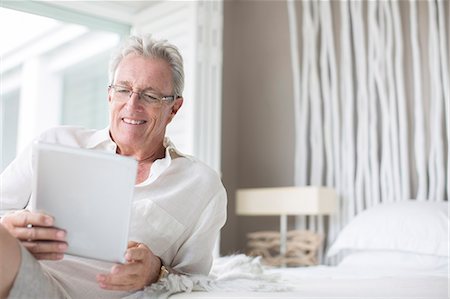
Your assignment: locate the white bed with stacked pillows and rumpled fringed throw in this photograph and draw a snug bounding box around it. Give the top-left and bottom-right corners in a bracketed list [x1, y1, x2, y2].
[128, 200, 449, 299]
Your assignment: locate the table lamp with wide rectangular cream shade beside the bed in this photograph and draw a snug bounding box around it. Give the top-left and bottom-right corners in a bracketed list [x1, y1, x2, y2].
[236, 186, 337, 266]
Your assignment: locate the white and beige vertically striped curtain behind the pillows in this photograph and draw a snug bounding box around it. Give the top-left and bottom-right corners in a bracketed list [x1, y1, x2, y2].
[287, 0, 450, 262]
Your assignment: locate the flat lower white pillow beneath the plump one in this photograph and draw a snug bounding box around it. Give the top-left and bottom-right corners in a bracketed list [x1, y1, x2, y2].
[339, 250, 448, 273]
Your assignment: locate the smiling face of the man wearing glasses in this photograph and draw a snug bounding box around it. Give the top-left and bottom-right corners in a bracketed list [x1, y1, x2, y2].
[108, 54, 183, 151]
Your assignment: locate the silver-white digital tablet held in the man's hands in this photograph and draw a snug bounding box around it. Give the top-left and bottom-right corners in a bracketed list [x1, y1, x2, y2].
[31, 142, 137, 263]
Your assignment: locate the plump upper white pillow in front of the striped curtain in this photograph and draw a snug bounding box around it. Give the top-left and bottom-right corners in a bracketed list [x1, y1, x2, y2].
[327, 200, 449, 257]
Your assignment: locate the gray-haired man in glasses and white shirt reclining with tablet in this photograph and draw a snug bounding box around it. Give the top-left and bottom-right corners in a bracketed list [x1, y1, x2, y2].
[0, 36, 226, 298]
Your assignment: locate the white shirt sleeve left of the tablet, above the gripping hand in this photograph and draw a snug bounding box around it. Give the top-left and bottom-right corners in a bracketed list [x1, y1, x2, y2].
[0, 144, 33, 214]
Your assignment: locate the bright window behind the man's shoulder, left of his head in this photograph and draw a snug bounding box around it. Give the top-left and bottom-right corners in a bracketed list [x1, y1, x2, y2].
[0, 8, 120, 171]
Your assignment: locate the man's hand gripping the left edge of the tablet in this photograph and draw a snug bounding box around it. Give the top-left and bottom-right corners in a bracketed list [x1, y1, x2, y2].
[0, 210, 67, 260]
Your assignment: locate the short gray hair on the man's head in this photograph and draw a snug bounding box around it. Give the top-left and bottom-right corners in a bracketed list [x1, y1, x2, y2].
[109, 34, 184, 97]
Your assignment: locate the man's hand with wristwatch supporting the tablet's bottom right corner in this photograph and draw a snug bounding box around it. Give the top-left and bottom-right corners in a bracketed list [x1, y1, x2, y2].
[96, 241, 161, 291]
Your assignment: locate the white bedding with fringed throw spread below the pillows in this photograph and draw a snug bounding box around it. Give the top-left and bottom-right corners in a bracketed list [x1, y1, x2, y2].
[125, 255, 449, 299]
